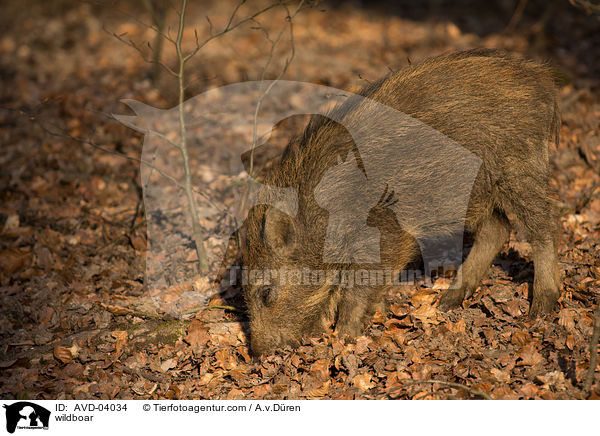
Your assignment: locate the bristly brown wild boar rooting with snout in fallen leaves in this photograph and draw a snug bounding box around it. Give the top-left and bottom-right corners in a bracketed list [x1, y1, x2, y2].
[241, 49, 560, 354]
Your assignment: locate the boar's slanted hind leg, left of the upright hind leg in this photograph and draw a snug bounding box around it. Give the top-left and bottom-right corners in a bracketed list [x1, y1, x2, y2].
[439, 212, 510, 310]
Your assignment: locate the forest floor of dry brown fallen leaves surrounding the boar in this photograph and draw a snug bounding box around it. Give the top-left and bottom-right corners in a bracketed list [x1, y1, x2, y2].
[0, 0, 600, 399]
